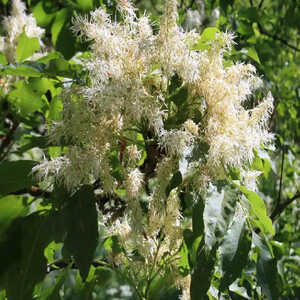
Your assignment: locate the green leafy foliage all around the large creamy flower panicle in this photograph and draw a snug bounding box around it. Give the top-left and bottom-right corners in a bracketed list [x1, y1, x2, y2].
[0, 0, 300, 300]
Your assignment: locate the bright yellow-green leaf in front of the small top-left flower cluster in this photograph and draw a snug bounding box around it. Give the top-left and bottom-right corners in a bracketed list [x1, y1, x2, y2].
[16, 31, 40, 62]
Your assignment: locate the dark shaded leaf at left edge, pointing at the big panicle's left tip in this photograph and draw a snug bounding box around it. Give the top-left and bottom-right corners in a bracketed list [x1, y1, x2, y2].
[0, 160, 37, 195]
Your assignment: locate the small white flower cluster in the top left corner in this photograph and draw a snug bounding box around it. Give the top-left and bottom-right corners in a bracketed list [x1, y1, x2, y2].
[0, 0, 45, 63]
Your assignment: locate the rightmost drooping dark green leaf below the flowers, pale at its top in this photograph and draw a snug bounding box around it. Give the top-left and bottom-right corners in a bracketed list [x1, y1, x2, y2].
[252, 232, 280, 300]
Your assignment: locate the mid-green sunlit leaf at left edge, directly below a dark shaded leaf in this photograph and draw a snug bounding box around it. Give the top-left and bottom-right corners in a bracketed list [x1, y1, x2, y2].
[0, 195, 27, 237]
